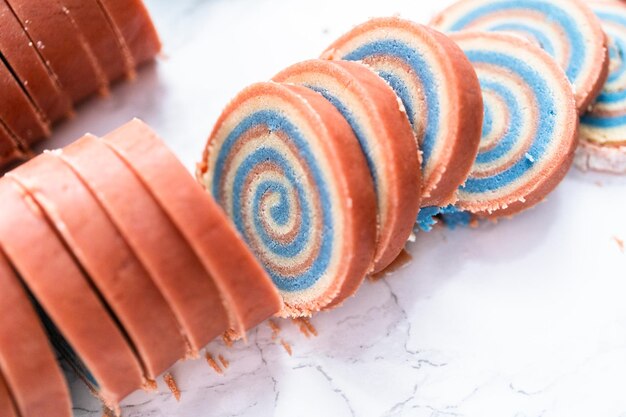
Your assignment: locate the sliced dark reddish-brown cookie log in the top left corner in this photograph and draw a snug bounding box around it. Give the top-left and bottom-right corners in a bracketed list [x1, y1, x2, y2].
[0, 0, 161, 165]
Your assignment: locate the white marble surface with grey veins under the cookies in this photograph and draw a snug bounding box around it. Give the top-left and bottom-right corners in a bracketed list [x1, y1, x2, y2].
[54, 0, 626, 417]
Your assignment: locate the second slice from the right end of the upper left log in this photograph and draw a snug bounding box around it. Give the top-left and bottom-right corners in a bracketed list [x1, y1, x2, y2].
[60, 0, 129, 83]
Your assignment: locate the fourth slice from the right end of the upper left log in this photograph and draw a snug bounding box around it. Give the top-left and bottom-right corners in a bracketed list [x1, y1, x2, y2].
[0, 0, 72, 123]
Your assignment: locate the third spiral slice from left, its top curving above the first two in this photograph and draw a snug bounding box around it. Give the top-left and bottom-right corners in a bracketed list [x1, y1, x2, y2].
[322, 18, 482, 207]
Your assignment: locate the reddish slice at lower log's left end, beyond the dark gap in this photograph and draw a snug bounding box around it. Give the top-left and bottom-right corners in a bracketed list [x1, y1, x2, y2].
[0, 247, 72, 417]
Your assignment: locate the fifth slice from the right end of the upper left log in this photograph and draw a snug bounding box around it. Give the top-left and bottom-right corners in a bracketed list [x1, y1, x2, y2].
[0, 60, 50, 149]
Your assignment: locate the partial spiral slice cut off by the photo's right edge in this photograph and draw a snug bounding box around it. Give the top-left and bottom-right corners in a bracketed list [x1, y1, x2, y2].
[580, 2, 626, 146]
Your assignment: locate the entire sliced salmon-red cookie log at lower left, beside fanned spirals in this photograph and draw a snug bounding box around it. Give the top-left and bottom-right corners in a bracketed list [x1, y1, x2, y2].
[0, 120, 282, 417]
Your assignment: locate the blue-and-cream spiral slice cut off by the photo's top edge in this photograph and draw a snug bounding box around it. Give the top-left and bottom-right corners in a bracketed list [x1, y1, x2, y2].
[431, 0, 609, 114]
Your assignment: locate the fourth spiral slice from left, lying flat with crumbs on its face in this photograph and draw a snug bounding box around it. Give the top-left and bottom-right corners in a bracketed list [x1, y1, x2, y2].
[452, 32, 578, 218]
